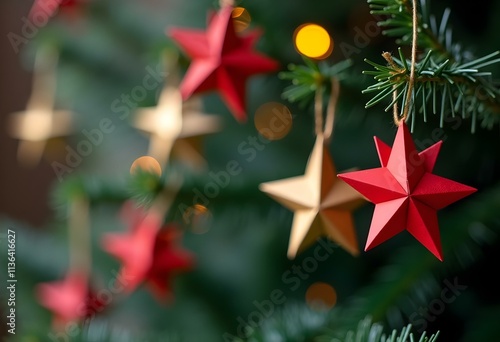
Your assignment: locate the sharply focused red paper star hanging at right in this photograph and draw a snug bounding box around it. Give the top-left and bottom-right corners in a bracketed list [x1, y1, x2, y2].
[338, 122, 476, 261]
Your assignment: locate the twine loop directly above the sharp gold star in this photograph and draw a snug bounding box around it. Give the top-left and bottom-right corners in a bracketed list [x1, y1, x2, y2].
[314, 77, 340, 141]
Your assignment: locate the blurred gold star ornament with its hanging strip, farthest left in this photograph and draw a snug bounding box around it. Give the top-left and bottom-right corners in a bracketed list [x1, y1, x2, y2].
[7, 50, 73, 166]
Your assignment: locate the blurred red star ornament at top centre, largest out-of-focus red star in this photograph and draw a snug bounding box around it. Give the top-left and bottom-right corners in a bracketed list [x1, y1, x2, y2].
[167, 6, 278, 122]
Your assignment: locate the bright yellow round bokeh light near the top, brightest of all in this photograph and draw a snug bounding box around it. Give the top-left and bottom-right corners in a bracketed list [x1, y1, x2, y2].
[294, 24, 333, 59]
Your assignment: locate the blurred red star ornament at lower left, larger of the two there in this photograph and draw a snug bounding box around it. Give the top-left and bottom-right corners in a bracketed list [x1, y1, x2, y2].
[102, 205, 194, 301]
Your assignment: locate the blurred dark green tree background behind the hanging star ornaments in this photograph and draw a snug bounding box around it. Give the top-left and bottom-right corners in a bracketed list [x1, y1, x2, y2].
[0, 0, 500, 342]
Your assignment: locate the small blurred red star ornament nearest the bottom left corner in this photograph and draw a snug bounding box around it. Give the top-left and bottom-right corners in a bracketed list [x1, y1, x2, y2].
[35, 272, 106, 330]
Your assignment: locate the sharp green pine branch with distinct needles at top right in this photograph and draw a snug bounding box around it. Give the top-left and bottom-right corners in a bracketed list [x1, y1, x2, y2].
[363, 0, 500, 132]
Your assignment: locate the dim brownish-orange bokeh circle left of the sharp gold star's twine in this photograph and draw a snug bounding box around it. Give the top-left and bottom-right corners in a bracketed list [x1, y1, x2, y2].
[254, 102, 293, 140]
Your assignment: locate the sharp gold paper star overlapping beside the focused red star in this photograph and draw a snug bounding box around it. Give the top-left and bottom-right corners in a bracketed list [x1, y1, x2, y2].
[259, 134, 365, 259]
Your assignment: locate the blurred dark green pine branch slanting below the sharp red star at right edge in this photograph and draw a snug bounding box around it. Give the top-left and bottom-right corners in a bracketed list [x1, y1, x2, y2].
[326, 185, 500, 330]
